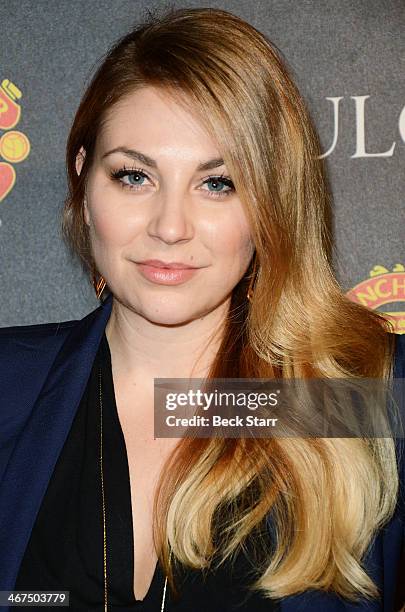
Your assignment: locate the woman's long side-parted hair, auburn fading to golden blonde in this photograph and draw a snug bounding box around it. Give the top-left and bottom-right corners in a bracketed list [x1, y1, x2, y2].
[62, 8, 398, 600]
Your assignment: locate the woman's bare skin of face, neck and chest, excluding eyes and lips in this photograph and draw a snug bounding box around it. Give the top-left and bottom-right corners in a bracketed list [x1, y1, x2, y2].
[77, 87, 254, 600]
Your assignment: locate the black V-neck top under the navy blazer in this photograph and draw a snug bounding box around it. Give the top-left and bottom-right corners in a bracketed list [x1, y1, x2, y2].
[14, 334, 279, 612]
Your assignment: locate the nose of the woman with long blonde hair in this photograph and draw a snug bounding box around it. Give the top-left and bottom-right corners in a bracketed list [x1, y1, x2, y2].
[147, 188, 194, 244]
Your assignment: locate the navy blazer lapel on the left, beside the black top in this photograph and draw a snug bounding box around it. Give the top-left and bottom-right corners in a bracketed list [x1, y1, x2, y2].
[0, 294, 112, 592]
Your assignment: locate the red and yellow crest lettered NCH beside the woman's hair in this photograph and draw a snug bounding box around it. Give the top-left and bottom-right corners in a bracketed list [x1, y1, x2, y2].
[346, 263, 405, 334]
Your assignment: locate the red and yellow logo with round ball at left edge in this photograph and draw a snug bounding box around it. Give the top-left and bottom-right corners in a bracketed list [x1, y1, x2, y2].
[0, 79, 31, 202]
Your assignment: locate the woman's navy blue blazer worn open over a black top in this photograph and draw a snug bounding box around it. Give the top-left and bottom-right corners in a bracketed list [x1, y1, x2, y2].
[0, 295, 405, 612]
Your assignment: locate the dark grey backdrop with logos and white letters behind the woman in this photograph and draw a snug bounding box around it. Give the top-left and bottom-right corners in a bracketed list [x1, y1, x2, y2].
[0, 0, 405, 333]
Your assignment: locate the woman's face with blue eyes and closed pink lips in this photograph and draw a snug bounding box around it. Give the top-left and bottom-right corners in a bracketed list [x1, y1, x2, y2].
[77, 87, 253, 324]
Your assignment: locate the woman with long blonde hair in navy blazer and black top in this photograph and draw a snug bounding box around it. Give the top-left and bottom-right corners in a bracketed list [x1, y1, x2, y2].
[0, 9, 405, 612]
